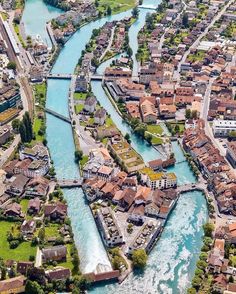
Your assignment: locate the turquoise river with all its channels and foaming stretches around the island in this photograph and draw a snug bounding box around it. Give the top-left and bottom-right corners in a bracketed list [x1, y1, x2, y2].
[23, 0, 207, 294]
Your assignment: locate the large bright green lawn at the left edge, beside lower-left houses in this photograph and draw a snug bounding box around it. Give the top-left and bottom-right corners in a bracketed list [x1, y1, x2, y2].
[0, 221, 36, 261]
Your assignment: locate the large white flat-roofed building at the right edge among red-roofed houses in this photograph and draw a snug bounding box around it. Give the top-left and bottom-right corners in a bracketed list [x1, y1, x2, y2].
[212, 119, 236, 137]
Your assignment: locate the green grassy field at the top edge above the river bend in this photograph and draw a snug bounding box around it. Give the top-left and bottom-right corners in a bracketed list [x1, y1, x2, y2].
[98, 0, 136, 13]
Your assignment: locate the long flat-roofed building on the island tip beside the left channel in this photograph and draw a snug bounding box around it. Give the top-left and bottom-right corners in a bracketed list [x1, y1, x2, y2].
[97, 207, 124, 247]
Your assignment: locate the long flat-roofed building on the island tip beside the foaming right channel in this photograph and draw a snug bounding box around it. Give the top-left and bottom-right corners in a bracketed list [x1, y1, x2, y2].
[128, 220, 162, 255]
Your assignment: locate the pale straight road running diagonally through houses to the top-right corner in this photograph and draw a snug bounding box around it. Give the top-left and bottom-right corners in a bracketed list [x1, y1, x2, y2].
[173, 0, 235, 83]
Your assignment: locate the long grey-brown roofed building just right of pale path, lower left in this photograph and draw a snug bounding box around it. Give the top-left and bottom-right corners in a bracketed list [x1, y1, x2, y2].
[42, 245, 67, 262]
